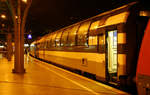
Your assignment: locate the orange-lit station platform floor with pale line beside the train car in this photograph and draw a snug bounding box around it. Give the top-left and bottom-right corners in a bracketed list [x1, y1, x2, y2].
[0, 55, 129, 95]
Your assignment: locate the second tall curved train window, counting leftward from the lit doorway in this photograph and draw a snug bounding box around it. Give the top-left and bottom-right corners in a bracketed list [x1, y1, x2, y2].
[68, 25, 80, 46]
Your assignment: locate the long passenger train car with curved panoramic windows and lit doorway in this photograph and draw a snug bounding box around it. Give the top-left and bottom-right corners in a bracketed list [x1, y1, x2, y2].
[30, 2, 149, 94]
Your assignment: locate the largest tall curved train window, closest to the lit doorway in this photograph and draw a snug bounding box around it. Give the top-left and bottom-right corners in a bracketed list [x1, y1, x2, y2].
[77, 21, 91, 46]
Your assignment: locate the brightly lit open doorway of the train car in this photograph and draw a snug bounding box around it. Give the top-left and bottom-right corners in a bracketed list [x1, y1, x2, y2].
[106, 30, 118, 82]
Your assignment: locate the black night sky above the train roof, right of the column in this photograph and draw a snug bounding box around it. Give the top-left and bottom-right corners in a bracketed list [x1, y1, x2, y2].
[26, 0, 137, 37]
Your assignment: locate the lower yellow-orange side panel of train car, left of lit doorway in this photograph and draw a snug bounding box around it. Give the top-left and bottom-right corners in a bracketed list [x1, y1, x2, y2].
[41, 51, 105, 79]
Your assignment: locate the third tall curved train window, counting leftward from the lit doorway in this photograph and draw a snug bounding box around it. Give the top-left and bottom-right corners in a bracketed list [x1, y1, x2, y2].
[61, 28, 71, 46]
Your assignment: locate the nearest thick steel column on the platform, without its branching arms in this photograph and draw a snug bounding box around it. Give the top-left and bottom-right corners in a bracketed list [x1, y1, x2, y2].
[13, 0, 25, 73]
